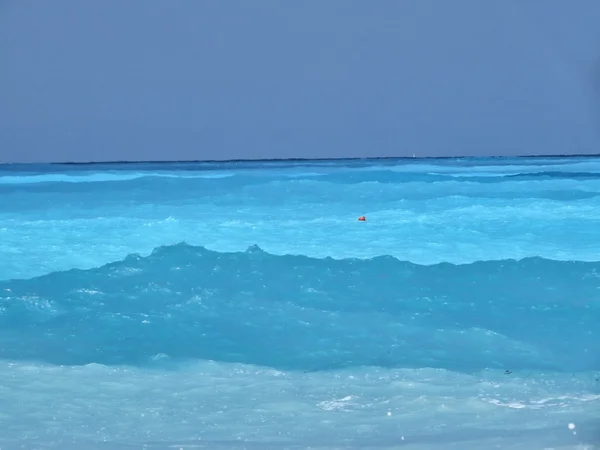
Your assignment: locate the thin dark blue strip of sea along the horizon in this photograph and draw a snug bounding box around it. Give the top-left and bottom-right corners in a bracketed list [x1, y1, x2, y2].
[0, 153, 600, 165]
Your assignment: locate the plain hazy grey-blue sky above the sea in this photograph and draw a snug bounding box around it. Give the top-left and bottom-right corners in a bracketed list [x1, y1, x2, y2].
[0, 0, 600, 162]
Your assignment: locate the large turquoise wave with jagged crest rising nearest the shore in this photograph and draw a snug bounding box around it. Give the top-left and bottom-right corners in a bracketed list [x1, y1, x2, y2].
[0, 243, 600, 371]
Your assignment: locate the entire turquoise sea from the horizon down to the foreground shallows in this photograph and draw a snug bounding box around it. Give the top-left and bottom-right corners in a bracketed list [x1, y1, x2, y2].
[0, 157, 600, 450]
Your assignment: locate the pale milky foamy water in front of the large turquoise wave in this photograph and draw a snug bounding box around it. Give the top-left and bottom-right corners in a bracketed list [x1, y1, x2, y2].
[0, 361, 600, 450]
